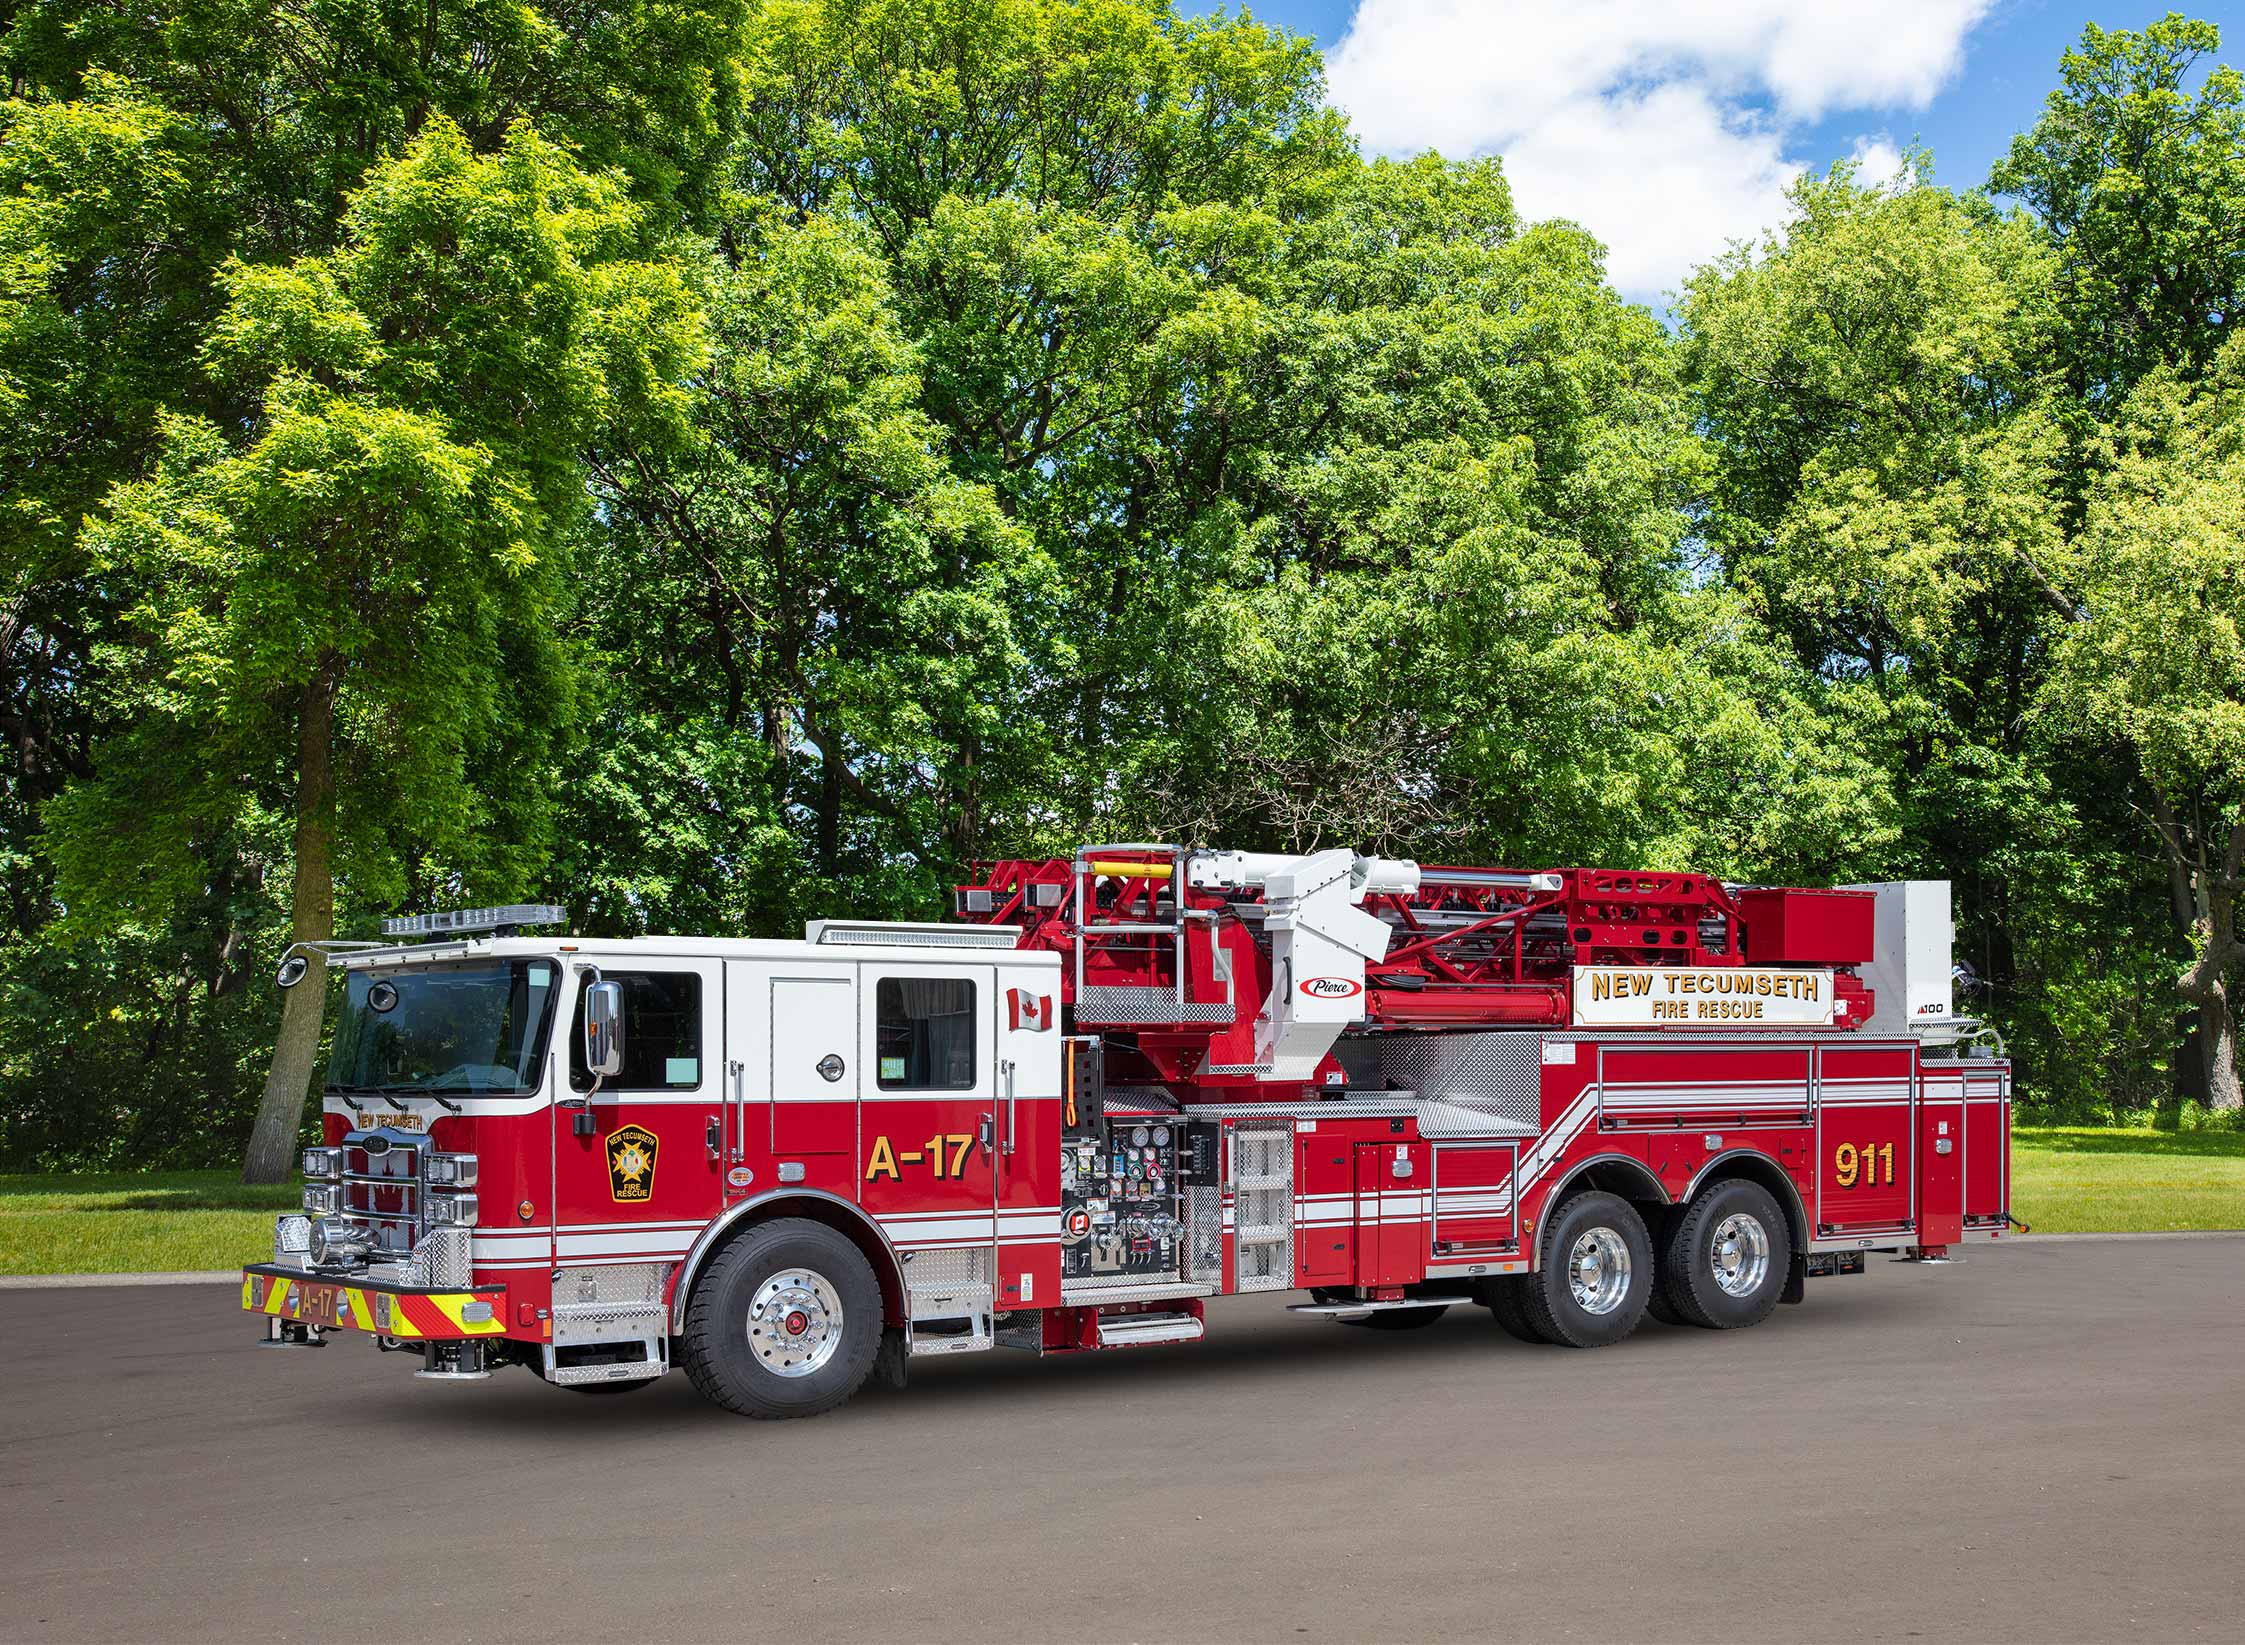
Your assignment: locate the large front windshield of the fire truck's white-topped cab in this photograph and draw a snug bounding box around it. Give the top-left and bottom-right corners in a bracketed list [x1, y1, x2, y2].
[328, 961, 559, 1093]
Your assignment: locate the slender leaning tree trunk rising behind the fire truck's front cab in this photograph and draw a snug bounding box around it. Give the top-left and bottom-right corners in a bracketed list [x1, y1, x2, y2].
[242, 658, 341, 1183]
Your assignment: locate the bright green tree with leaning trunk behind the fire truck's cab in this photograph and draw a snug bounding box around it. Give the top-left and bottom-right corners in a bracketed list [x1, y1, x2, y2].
[49, 119, 691, 1180]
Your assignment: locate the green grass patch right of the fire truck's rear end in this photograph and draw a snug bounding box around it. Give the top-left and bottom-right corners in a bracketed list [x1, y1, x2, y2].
[2012, 1124, 2245, 1234]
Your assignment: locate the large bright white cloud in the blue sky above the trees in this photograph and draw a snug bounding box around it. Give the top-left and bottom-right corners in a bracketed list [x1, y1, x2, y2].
[1327, 0, 1994, 298]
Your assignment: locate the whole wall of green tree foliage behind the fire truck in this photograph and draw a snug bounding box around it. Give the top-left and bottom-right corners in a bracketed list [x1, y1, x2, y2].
[0, 0, 2245, 1160]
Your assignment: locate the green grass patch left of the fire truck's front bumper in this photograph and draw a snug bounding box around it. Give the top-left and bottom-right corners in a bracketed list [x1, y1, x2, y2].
[0, 1171, 301, 1275]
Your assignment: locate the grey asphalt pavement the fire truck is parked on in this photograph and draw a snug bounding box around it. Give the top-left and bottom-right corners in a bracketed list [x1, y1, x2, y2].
[0, 1239, 2245, 1645]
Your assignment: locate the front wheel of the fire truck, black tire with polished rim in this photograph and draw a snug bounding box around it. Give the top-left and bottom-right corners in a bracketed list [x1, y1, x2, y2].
[678, 1216, 882, 1418]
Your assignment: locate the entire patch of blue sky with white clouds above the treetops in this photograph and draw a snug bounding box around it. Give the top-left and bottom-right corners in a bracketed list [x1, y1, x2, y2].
[1179, 0, 2245, 307]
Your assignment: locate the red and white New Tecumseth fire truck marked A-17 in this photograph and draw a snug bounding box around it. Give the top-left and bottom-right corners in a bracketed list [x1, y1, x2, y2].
[242, 844, 2012, 1416]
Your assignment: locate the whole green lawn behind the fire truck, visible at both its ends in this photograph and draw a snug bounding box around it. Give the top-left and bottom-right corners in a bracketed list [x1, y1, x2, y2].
[0, 1127, 2245, 1275]
